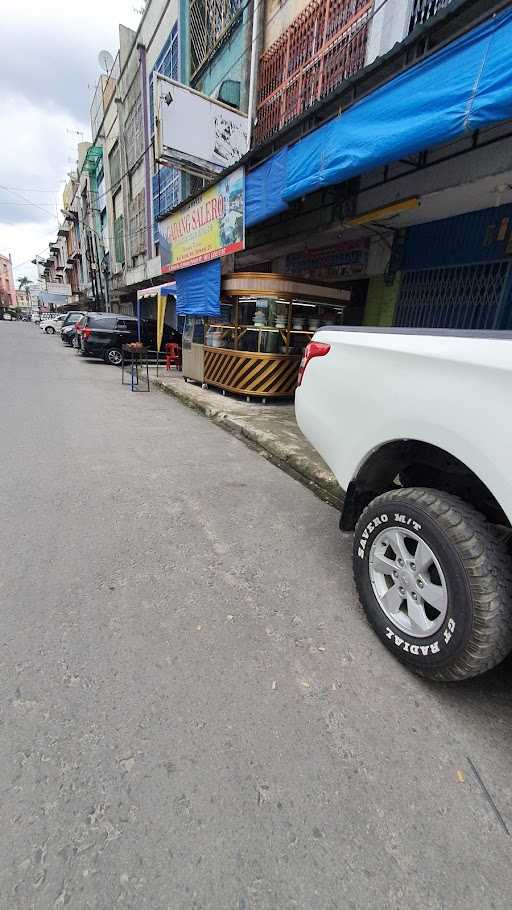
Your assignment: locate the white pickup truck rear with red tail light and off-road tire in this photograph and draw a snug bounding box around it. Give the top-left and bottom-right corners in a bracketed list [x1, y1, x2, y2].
[295, 327, 512, 680]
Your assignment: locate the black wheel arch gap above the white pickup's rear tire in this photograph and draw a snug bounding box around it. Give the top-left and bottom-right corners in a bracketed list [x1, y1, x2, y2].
[340, 439, 510, 531]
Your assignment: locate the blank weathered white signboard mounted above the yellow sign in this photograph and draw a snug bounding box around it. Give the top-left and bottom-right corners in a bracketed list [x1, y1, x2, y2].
[154, 73, 248, 176]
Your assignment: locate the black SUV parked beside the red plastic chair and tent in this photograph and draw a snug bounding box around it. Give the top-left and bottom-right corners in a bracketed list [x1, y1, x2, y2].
[79, 313, 181, 366]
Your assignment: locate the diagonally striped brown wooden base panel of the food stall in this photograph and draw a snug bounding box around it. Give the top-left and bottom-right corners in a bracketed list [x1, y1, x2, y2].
[204, 347, 300, 398]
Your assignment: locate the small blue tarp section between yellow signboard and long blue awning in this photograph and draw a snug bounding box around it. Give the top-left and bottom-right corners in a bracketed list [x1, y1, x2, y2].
[245, 148, 288, 227]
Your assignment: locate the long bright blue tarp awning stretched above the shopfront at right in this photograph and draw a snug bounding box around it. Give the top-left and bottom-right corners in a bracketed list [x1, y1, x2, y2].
[283, 10, 512, 201]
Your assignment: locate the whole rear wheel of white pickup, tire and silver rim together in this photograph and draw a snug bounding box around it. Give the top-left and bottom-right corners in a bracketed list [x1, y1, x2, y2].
[353, 487, 512, 681]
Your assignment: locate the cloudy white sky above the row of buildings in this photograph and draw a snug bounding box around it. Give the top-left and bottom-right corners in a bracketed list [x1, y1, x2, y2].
[0, 0, 142, 280]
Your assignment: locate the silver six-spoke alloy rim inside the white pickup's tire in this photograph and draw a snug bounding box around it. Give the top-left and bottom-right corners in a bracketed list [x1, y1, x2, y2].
[368, 527, 448, 638]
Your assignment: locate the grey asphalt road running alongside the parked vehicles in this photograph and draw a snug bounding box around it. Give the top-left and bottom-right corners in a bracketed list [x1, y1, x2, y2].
[0, 322, 512, 910]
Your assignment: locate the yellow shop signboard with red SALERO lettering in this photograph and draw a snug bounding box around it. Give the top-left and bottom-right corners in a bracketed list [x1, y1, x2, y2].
[158, 168, 245, 273]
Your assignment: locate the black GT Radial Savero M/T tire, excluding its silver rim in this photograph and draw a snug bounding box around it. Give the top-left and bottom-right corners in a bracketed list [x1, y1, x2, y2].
[353, 487, 512, 682]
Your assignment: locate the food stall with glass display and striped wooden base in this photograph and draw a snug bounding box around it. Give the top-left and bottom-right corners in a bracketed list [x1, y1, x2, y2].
[203, 272, 350, 399]
